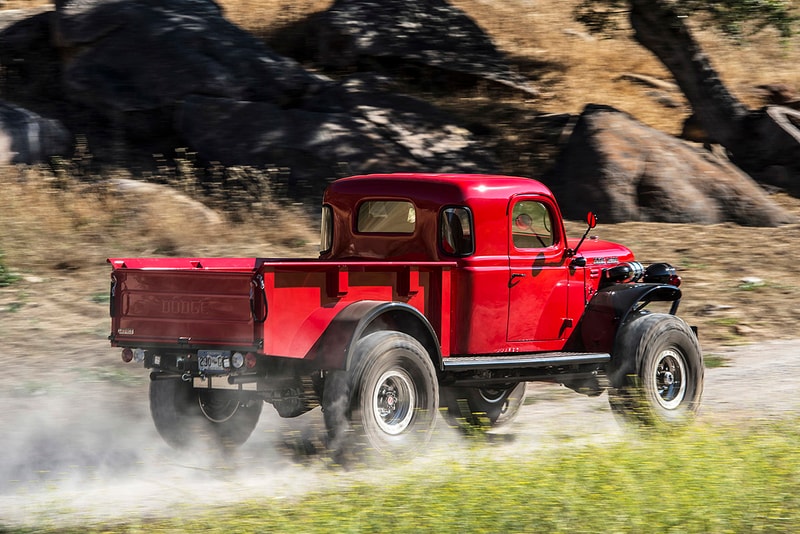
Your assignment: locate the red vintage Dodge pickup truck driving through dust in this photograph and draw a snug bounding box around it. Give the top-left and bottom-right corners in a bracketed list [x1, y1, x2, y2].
[109, 174, 703, 458]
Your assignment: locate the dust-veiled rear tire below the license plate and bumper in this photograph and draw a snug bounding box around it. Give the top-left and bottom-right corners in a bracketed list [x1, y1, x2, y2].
[150, 377, 264, 449]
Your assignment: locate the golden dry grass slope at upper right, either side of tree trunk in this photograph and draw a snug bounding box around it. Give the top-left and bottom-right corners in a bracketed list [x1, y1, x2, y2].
[453, 0, 800, 134]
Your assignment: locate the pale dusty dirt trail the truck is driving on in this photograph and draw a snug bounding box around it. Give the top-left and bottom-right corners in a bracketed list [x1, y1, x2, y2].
[0, 339, 800, 530]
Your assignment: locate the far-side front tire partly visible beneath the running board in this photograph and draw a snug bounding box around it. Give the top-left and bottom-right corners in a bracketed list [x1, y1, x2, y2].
[439, 382, 526, 430]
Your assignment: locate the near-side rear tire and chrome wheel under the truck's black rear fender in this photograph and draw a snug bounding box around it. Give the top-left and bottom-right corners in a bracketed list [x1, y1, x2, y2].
[322, 331, 439, 465]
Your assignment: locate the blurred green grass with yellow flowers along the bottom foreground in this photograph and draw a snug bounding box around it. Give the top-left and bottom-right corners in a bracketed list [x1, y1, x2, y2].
[32, 420, 800, 533]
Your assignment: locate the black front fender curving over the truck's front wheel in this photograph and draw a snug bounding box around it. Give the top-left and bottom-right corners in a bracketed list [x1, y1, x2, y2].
[580, 283, 681, 352]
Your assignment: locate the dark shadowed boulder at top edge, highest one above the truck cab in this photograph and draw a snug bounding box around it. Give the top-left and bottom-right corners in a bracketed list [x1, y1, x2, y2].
[309, 0, 538, 96]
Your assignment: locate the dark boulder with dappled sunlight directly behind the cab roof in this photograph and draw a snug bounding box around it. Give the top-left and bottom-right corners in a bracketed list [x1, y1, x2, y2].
[176, 74, 497, 197]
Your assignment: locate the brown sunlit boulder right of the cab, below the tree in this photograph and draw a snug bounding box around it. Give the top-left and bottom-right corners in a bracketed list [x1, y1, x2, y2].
[546, 104, 794, 226]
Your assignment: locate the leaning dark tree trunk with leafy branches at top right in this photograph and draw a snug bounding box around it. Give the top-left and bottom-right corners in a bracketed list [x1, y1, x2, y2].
[575, 0, 800, 195]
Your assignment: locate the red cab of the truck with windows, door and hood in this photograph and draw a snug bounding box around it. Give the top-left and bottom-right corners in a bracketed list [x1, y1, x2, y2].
[321, 174, 633, 355]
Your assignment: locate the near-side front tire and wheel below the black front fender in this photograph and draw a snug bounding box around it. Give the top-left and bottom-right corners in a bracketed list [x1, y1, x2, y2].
[608, 313, 704, 427]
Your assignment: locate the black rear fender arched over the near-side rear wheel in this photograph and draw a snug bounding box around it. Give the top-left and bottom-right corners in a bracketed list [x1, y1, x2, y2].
[306, 300, 442, 370]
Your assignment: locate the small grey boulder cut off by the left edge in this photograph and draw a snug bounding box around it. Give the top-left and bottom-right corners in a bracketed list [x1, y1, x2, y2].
[0, 101, 72, 165]
